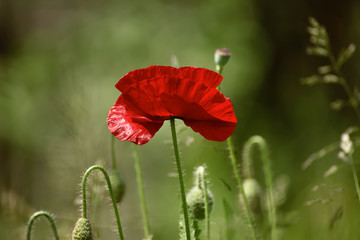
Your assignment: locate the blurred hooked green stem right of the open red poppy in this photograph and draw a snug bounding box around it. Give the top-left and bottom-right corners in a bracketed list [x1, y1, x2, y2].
[243, 136, 277, 240]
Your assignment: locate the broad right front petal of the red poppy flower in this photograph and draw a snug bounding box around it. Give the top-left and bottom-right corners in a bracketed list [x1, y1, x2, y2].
[161, 79, 237, 141]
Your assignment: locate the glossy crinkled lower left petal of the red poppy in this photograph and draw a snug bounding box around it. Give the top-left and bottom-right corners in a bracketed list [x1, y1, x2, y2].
[107, 94, 164, 145]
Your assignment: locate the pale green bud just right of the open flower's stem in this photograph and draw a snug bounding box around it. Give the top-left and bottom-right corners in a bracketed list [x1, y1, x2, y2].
[186, 186, 214, 220]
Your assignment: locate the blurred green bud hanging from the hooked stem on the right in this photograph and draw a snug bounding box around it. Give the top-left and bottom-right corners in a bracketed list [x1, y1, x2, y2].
[240, 178, 261, 211]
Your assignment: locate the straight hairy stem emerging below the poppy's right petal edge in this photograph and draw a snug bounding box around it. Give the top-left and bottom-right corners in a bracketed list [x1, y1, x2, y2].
[227, 136, 258, 240]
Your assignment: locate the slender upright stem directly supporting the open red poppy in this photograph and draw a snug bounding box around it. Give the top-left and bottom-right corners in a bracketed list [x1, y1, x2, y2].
[170, 117, 191, 240]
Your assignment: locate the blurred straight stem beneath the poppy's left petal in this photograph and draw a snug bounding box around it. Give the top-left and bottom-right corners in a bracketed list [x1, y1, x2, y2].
[134, 145, 151, 240]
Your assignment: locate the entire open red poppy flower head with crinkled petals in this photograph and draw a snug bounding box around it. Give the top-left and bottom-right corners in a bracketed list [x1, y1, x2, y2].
[107, 66, 237, 145]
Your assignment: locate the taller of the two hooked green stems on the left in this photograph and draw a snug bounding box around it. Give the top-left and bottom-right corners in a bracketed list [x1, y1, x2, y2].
[81, 165, 124, 240]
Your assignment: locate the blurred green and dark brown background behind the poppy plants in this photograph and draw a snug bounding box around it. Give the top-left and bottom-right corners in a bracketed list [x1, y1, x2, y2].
[0, 0, 360, 240]
